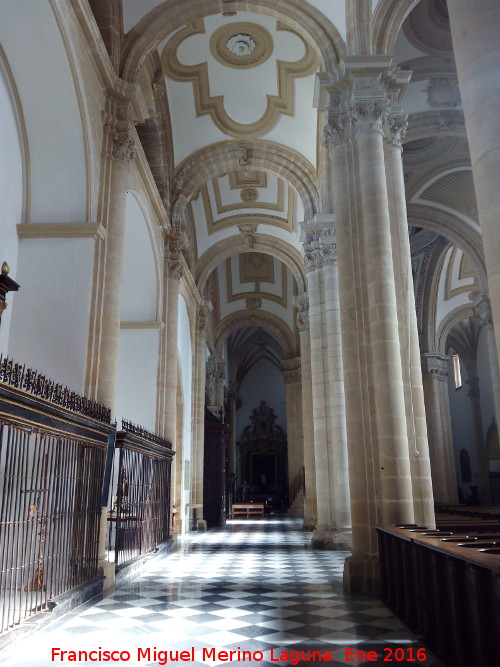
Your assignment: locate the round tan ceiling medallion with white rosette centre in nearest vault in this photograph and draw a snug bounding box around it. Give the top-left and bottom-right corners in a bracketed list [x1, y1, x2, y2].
[210, 23, 273, 69]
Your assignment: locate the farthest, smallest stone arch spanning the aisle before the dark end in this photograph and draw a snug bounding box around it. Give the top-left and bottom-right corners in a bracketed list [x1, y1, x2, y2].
[215, 310, 298, 359]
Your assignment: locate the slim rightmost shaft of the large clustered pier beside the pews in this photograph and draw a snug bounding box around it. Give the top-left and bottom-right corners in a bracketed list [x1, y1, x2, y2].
[384, 118, 434, 525]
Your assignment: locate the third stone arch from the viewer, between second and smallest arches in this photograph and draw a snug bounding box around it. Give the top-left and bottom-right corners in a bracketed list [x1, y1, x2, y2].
[196, 233, 306, 294]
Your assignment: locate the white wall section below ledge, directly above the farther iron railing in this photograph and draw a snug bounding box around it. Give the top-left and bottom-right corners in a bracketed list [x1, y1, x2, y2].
[116, 329, 159, 431]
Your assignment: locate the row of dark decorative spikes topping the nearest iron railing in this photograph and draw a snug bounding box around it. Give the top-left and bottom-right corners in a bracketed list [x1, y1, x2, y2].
[0, 354, 111, 424]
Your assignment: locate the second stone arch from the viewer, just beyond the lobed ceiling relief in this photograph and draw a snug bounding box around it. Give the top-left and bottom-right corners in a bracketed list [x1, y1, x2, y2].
[172, 139, 319, 224]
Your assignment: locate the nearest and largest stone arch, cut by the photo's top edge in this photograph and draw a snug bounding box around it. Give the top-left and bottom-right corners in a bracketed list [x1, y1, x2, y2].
[121, 0, 346, 83]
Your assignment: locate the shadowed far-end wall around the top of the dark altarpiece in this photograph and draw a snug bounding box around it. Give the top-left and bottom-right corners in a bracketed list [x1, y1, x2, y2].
[236, 359, 286, 438]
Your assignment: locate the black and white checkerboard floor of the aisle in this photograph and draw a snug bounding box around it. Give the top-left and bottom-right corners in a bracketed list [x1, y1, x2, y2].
[0, 517, 441, 667]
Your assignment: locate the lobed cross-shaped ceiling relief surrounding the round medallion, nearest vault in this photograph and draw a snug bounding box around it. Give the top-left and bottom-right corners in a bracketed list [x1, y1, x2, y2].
[162, 19, 319, 138]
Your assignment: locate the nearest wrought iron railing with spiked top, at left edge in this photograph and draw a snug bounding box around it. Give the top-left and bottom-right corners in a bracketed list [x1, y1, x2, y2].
[0, 359, 112, 634]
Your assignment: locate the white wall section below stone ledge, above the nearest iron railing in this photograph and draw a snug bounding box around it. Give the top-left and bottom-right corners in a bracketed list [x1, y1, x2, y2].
[9, 239, 94, 392]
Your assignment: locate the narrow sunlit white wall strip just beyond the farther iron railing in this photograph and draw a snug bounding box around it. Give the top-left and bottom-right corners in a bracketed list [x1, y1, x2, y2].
[177, 296, 193, 530]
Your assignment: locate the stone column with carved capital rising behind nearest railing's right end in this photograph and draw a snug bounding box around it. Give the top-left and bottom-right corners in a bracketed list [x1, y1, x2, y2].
[96, 108, 136, 410]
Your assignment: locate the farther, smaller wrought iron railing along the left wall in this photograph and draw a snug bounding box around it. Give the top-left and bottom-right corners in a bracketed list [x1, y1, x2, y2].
[108, 421, 174, 566]
